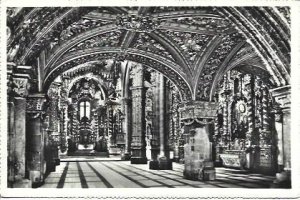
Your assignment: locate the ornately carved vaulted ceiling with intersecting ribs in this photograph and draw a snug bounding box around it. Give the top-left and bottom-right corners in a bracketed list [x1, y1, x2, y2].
[7, 7, 290, 100]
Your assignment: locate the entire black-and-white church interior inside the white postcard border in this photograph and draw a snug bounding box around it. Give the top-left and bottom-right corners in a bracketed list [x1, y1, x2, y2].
[6, 7, 291, 188]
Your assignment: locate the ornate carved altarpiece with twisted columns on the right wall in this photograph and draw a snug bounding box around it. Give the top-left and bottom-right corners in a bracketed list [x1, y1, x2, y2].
[214, 70, 276, 169]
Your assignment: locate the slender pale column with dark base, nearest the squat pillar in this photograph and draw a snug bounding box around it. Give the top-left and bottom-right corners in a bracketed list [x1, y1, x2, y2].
[149, 73, 172, 170]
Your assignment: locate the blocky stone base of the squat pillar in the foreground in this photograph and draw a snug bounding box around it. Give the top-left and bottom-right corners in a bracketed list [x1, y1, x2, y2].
[183, 160, 216, 181]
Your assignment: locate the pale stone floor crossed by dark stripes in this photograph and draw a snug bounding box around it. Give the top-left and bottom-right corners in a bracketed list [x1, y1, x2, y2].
[41, 159, 274, 188]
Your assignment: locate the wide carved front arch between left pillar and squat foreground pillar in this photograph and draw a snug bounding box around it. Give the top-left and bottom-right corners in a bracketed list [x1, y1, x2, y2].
[44, 47, 192, 100]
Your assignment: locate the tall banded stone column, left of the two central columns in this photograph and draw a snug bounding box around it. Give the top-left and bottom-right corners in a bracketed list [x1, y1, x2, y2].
[130, 64, 147, 164]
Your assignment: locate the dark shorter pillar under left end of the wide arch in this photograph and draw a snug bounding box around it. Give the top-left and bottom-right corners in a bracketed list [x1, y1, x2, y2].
[26, 94, 46, 187]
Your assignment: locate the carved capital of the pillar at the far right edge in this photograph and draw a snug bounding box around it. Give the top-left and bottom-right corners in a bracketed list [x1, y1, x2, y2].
[270, 85, 291, 110]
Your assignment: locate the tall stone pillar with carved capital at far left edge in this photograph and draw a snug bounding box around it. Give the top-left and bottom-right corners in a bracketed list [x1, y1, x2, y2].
[7, 63, 31, 188]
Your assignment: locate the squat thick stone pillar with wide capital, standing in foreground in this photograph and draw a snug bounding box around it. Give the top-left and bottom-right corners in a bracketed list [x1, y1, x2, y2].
[179, 101, 217, 180]
